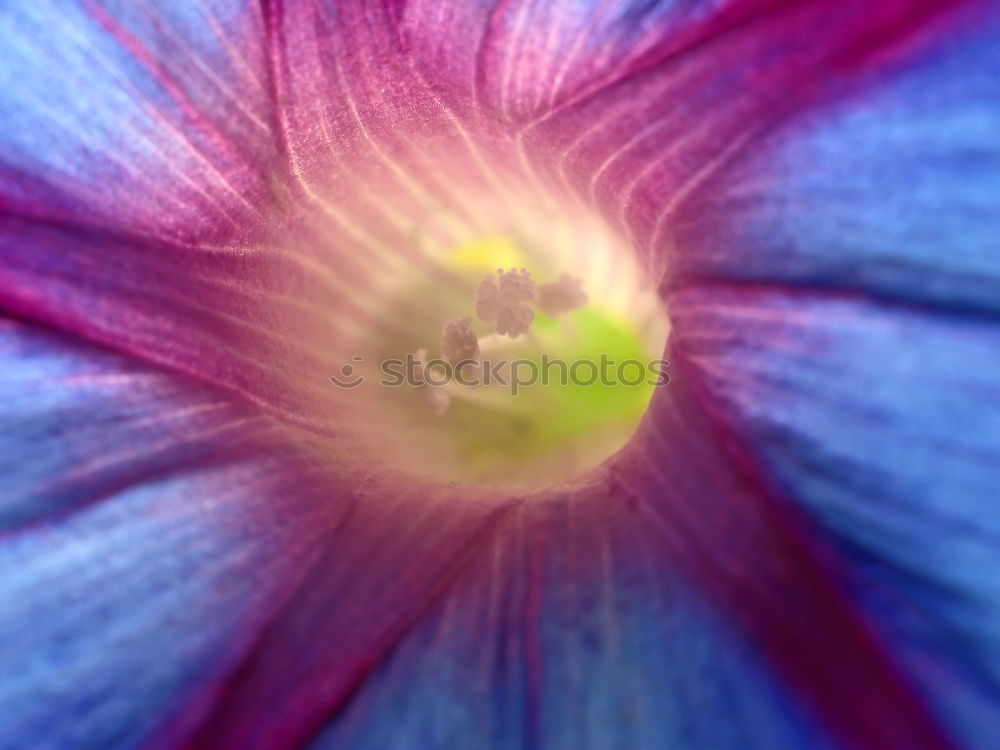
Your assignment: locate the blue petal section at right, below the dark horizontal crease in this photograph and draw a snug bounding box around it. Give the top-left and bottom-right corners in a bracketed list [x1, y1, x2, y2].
[673, 287, 1000, 748]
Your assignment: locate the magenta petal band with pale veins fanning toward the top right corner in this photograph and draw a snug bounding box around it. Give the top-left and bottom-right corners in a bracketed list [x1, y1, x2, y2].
[519, 1, 980, 274]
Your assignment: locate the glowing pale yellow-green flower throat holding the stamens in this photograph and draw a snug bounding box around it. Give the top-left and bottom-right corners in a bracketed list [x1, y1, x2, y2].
[340, 212, 666, 490]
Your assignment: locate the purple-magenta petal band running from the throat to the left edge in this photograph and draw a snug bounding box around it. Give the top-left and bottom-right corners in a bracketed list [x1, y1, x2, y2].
[0, 215, 363, 432]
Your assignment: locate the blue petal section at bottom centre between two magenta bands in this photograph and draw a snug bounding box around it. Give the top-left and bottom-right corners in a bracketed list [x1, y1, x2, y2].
[310, 497, 837, 750]
